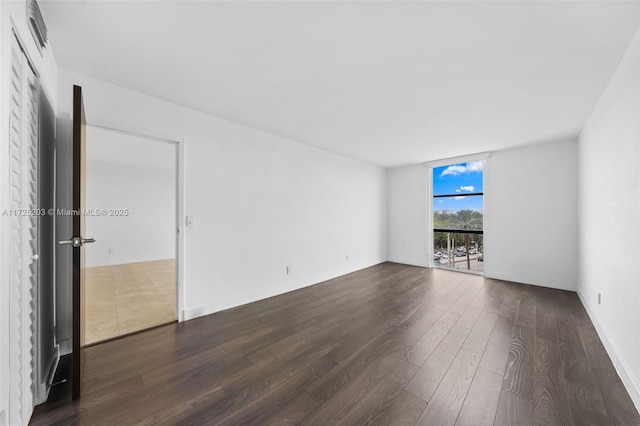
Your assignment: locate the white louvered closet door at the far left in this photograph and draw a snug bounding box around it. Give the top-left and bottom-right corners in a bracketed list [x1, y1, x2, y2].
[9, 35, 38, 425]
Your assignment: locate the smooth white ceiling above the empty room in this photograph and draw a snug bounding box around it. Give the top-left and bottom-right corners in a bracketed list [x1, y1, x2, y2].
[41, 0, 640, 167]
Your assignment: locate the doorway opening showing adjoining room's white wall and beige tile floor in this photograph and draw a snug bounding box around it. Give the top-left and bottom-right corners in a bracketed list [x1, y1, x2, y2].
[82, 125, 178, 345]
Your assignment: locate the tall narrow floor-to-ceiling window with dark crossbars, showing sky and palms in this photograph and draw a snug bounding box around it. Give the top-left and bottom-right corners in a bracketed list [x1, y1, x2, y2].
[430, 160, 484, 272]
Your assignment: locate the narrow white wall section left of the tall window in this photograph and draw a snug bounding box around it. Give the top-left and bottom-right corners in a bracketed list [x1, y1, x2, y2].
[387, 164, 429, 266]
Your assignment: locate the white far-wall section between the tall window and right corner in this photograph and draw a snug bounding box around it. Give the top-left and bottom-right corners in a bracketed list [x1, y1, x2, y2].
[484, 140, 578, 291]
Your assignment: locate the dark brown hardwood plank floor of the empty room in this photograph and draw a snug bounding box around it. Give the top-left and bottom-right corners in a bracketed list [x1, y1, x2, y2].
[32, 263, 640, 426]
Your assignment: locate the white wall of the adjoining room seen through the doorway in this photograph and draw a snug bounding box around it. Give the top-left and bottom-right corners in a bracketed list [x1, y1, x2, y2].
[85, 126, 177, 267]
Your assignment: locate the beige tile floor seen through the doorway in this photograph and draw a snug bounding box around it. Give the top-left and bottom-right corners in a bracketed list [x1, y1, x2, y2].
[84, 259, 176, 345]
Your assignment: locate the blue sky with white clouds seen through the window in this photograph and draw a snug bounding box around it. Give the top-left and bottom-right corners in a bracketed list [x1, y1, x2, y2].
[433, 161, 484, 211]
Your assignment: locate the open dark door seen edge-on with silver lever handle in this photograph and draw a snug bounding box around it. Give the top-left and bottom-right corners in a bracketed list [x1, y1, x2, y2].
[59, 86, 94, 399]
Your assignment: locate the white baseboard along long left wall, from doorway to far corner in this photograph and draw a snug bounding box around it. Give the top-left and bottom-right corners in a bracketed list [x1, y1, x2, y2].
[181, 260, 386, 321]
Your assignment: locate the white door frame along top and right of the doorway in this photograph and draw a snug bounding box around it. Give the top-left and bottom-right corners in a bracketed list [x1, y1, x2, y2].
[87, 117, 186, 322]
